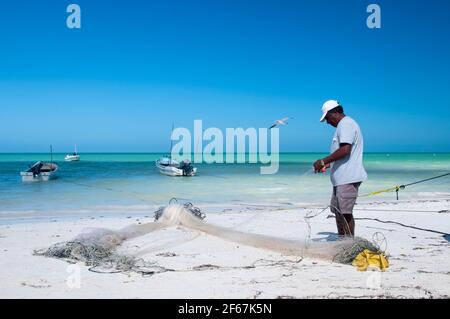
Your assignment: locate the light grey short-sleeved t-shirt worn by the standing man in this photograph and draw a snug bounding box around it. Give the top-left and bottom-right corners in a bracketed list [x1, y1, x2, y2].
[330, 116, 367, 186]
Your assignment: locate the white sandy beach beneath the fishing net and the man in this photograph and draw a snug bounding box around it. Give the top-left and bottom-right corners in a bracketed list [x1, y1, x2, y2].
[0, 199, 450, 298]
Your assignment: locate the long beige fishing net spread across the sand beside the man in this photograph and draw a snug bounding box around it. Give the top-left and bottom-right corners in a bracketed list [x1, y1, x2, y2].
[35, 203, 380, 275]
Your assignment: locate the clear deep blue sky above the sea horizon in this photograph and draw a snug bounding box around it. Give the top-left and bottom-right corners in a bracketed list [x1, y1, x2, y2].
[0, 0, 450, 152]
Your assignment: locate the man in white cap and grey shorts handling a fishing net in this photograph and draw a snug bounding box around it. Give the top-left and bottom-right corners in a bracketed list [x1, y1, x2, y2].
[314, 100, 367, 236]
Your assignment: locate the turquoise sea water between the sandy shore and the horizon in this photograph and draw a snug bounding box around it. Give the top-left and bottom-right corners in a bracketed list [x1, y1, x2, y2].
[0, 153, 450, 222]
